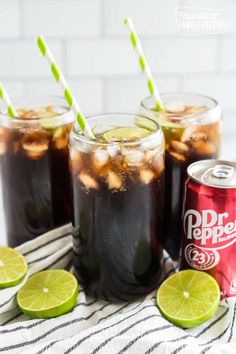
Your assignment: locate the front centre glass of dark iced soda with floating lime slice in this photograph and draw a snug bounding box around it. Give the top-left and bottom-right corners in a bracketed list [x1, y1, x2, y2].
[70, 114, 164, 301]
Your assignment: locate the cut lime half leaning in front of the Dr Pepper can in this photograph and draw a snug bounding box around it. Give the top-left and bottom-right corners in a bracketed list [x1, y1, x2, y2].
[157, 270, 220, 328]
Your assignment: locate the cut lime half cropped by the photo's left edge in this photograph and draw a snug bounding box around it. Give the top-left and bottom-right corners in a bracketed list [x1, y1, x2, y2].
[0, 247, 27, 288]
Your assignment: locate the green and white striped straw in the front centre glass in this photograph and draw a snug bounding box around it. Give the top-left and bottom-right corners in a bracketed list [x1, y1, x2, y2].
[37, 36, 95, 139]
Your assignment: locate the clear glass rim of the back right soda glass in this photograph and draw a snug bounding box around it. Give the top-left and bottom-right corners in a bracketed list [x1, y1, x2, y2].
[141, 91, 221, 120]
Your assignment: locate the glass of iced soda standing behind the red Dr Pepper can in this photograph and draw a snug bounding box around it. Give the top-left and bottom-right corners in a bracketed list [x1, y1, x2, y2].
[141, 93, 222, 260]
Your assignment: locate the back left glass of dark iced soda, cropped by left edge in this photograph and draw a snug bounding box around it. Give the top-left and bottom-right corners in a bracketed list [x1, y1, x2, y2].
[0, 96, 73, 247]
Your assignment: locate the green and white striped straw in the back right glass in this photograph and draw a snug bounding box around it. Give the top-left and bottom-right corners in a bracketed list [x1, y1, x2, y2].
[124, 17, 164, 112]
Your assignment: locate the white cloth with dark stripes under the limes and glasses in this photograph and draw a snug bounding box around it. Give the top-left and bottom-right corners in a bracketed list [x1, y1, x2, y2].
[0, 225, 236, 354]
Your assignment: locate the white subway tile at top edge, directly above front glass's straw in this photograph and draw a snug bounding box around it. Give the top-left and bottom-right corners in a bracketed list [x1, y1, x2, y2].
[22, 0, 102, 39]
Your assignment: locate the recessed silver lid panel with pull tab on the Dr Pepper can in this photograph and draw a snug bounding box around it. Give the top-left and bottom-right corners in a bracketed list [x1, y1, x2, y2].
[201, 165, 236, 187]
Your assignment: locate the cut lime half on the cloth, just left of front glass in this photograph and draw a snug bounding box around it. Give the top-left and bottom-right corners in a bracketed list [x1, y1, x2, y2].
[17, 269, 78, 318]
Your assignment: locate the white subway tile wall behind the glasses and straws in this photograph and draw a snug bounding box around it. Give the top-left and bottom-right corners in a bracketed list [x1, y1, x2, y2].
[0, 0, 236, 244]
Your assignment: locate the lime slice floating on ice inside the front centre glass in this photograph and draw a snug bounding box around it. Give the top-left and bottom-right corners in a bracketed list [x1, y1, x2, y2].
[103, 127, 150, 141]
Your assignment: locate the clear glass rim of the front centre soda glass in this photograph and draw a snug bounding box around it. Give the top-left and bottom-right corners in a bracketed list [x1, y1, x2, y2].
[71, 112, 163, 146]
